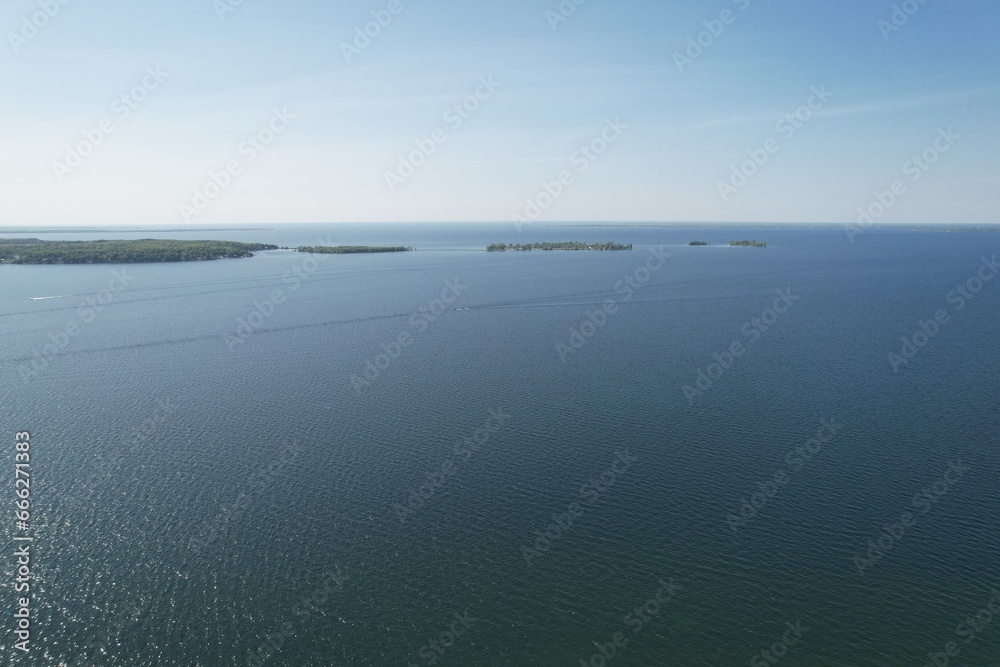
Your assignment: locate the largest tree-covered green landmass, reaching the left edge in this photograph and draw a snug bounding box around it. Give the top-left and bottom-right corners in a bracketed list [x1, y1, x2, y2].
[0, 239, 278, 264]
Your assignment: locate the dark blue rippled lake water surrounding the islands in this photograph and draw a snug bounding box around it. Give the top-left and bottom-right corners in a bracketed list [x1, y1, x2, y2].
[0, 225, 1000, 667]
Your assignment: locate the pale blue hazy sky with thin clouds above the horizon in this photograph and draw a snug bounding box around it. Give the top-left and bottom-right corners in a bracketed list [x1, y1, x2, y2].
[0, 0, 1000, 226]
